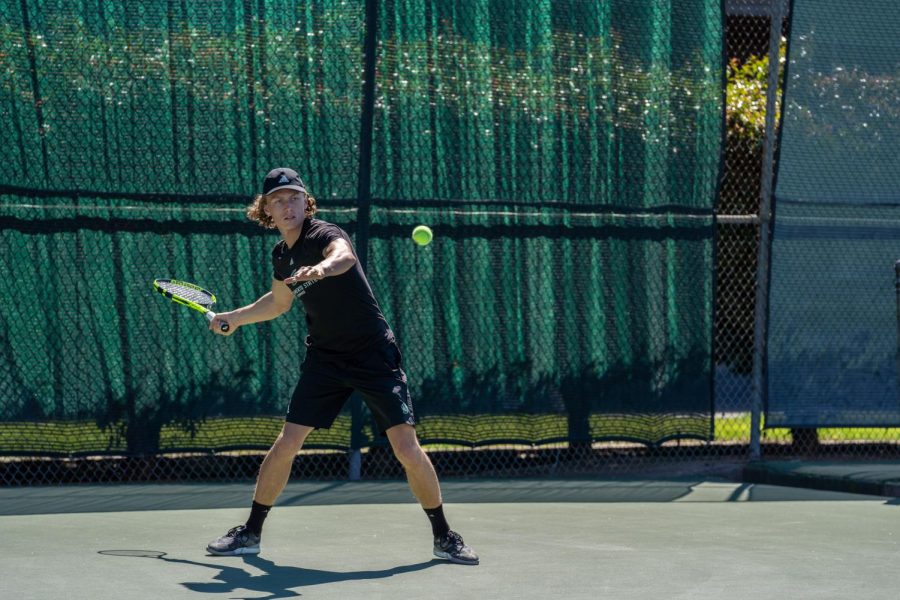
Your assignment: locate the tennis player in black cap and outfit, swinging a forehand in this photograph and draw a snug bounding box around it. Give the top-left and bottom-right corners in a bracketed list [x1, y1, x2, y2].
[207, 168, 478, 565]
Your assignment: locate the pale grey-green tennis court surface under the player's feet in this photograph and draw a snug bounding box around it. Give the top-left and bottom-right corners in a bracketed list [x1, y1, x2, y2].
[0, 479, 900, 600]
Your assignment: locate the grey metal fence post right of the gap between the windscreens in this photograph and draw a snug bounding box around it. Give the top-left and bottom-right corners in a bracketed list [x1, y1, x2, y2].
[750, 0, 784, 460]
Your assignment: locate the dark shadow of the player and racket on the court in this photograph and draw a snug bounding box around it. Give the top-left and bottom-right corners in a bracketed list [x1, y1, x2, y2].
[98, 550, 446, 600]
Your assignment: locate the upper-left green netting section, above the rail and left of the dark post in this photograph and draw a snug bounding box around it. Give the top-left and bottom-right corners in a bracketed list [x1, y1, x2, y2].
[0, 0, 364, 198]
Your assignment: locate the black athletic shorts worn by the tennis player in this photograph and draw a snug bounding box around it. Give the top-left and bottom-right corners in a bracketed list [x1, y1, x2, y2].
[285, 340, 416, 431]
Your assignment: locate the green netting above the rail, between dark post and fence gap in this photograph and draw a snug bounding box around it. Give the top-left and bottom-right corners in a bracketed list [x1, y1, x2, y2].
[372, 0, 722, 210]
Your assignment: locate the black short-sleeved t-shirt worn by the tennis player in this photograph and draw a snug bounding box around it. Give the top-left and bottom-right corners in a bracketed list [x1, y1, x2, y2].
[272, 218, 394, 355]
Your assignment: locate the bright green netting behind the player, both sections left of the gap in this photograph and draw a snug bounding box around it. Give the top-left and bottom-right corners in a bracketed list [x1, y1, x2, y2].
[0, 0, 722, 454]
